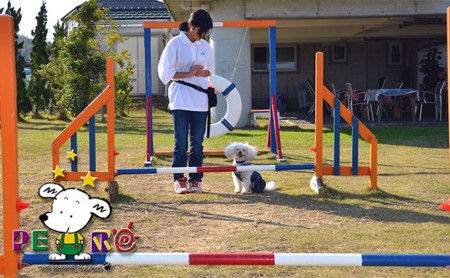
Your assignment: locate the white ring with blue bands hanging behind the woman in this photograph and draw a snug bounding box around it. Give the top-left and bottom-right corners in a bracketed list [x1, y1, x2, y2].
[205, 75, 242, 138]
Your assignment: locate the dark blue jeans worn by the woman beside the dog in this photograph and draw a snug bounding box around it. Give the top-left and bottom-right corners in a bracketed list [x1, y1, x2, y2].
[171, 110, 208, 181]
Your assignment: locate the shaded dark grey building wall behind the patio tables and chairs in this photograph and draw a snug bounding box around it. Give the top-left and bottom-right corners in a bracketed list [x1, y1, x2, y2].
[252, 41, 421, 112]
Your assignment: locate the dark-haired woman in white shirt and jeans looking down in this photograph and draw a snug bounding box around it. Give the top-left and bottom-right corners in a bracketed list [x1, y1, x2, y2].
[158, 9, 215, 194]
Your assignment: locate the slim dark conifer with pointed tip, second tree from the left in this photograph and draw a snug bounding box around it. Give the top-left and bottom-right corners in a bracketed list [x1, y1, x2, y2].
[28, 1, 51, 117]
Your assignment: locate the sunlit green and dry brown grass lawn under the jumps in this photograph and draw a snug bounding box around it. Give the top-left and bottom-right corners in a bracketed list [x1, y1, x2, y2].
[1, 100, 450, 277]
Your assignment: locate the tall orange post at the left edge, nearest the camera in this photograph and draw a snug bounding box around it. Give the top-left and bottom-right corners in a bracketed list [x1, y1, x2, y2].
[0, 15, 20, 277]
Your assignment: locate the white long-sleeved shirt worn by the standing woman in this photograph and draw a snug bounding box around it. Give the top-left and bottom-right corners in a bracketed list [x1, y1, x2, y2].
[158, 32, 215, 111]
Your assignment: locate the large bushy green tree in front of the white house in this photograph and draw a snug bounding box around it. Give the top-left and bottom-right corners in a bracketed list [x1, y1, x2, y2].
[42, 0, 134, 116]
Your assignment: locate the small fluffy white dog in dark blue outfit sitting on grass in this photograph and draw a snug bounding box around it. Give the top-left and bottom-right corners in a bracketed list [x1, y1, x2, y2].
[225, 142, 277, 194]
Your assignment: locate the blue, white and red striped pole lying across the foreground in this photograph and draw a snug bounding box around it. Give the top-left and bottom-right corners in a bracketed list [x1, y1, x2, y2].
[22, 253, 450, 267]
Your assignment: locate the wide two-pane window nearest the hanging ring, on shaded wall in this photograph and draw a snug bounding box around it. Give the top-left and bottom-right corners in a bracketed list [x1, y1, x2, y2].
[252, 45, 297, 72]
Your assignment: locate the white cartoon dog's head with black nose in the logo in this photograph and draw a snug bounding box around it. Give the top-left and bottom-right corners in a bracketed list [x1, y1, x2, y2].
[39, 182, 111, 233]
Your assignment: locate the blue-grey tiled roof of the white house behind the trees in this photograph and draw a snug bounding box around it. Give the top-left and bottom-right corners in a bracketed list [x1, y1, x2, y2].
[62, 0, 170, 21]
